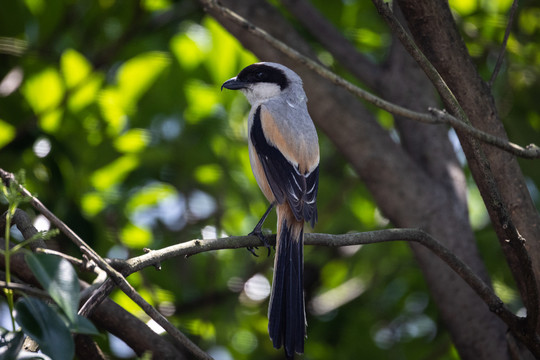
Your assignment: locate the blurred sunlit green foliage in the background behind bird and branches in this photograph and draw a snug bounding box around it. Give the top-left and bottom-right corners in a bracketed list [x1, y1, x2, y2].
[0, 0, 540, 359]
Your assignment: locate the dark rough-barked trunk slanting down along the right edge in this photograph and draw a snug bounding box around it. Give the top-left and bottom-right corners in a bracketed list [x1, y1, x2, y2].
[398, 0, 540, 330]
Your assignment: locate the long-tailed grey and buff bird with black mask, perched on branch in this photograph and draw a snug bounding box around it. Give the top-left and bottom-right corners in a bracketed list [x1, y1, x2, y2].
[221, 62, 320, 359]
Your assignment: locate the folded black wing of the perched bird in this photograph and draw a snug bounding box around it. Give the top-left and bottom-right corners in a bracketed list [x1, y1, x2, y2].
[249, 106, 319, 227]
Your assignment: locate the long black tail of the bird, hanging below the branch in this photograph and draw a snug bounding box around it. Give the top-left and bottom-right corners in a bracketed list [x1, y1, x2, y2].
[268, 219, 306, 359]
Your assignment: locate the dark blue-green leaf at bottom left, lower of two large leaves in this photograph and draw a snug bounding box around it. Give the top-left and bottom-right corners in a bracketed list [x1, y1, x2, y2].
[15, 297, 75, 360]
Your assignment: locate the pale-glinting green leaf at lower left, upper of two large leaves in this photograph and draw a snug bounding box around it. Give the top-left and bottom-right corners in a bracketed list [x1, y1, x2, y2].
[25, 254, 80, 323]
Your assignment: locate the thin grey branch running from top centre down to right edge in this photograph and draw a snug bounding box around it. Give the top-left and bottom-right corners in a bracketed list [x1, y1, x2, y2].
[201, 0, 540, 159]
